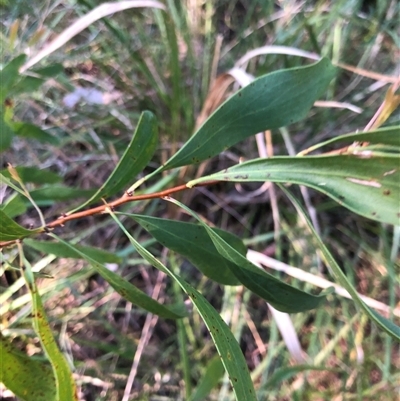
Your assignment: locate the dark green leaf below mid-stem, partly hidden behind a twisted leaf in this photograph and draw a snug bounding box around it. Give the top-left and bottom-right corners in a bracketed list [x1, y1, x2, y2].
[125, 213, 241, 285]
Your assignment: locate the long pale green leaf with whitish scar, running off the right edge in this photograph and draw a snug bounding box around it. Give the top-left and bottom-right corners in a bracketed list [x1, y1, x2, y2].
[187, 152, 400, 225]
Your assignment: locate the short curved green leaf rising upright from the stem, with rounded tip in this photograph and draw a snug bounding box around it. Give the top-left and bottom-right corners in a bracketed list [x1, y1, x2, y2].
[70, 111, 158, 212]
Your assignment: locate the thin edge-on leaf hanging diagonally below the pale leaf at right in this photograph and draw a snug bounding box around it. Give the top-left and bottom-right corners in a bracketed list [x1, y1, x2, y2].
[280, 185, 400, 342]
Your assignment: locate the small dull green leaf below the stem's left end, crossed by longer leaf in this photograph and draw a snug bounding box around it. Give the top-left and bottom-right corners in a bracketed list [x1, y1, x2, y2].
[24, 238, 122, 263]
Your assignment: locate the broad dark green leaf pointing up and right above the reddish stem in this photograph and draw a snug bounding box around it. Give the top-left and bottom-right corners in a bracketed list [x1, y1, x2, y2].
[162, 59, 335, 170]
